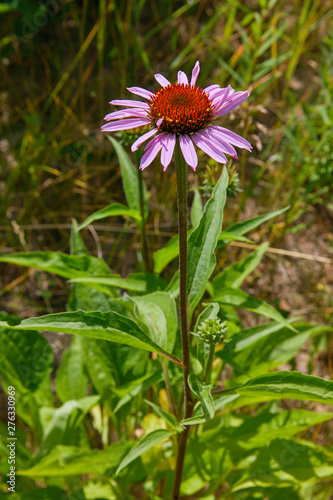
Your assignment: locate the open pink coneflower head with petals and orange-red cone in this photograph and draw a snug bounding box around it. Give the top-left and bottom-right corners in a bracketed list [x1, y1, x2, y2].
[101, 61, 251, 170]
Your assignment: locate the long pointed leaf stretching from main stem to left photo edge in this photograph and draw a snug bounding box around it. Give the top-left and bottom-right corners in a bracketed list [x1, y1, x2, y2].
[0, 311, 181, 364]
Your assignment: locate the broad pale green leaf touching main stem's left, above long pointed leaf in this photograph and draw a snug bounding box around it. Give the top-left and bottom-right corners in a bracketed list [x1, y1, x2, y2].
[131, 292, 178, 353]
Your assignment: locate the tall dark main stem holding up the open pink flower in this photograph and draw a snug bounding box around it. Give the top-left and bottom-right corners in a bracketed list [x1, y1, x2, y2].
[172, 141, 193, 500]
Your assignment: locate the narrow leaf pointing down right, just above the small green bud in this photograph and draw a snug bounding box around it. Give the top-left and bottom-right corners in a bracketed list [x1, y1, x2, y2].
[212, 288, 296, 331]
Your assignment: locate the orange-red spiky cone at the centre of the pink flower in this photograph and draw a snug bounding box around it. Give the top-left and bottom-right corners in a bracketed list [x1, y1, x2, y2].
[149, 83, 214, 135]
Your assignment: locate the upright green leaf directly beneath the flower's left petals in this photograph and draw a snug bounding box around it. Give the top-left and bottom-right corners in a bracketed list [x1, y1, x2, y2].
[107, 135, 148, 222]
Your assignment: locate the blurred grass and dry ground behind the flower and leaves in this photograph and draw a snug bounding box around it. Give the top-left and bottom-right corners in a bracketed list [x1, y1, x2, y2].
[0, 0, 333, 332]
